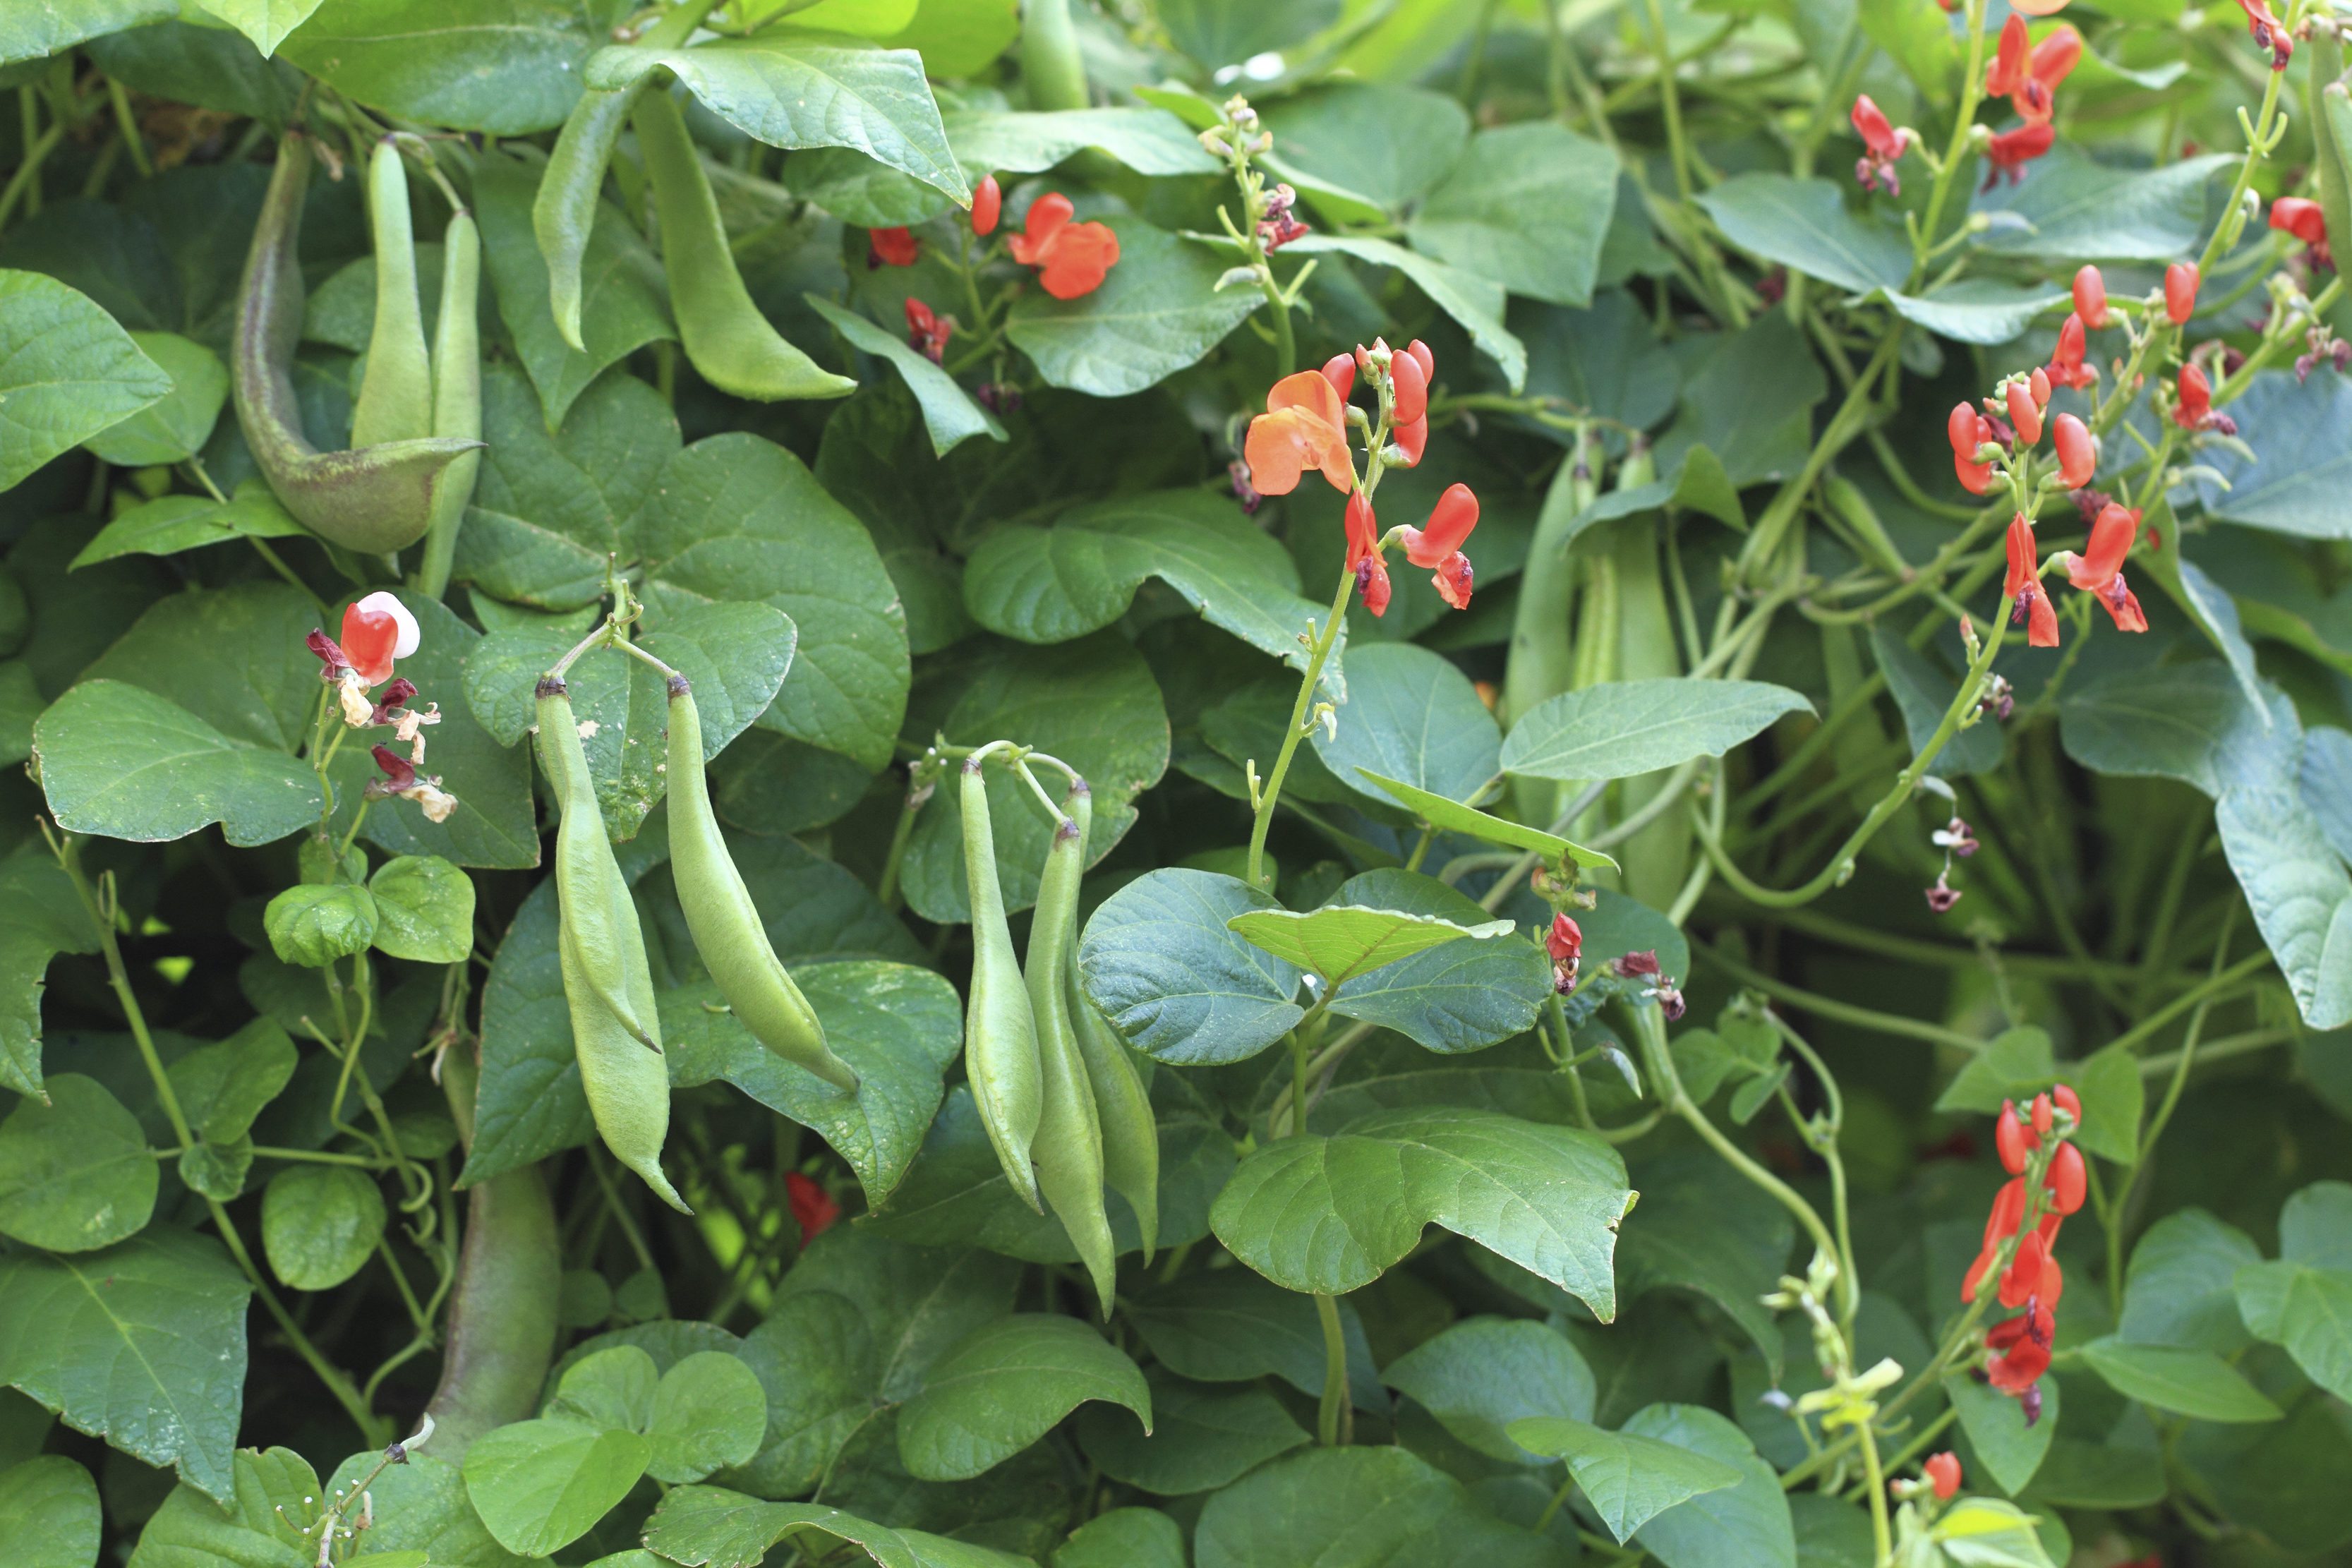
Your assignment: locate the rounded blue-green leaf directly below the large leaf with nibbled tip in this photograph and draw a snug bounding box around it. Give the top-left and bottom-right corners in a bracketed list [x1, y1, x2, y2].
[1380, 1317, 1592, 1464]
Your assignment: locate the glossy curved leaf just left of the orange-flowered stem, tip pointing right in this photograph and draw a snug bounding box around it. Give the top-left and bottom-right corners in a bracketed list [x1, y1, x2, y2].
[965, 489, 1345, 686]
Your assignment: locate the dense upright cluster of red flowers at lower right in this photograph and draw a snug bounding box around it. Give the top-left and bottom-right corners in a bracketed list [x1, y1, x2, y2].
[1959, 1084, 2089, 1427]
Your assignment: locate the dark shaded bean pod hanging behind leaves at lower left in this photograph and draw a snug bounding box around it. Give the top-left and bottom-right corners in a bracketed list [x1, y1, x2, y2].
[426, 1044, 565, 1464]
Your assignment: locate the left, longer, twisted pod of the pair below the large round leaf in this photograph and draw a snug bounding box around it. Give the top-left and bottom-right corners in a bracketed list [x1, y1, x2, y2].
[538, 680, 694, 1213]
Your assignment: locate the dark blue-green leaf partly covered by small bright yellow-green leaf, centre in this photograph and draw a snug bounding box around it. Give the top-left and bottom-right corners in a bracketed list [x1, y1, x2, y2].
[1326, 867, 1552, 1053]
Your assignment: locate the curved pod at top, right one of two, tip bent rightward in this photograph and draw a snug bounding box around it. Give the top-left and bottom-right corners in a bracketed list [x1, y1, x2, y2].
[635, 92, 859, 402]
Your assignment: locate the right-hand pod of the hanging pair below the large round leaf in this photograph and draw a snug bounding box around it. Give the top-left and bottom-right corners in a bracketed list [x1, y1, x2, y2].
[670, 675, 859, 1093]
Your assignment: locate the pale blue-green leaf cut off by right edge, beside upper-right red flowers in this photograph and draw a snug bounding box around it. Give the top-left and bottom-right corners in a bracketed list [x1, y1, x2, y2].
[2197, 369, 2352, 538]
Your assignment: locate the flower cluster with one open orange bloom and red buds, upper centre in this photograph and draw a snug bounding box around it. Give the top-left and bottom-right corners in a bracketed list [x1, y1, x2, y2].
[1235, 339, 1477, 616]
